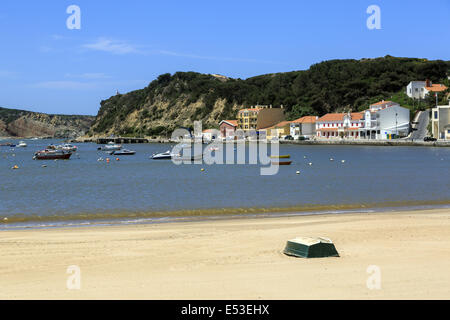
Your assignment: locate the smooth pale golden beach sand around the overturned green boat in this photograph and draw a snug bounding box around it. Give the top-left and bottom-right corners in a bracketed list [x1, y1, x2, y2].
[0, 209, 450, 299]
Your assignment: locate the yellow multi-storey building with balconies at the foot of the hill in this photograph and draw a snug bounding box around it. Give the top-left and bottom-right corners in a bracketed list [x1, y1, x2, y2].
[237, 106, 284, 131]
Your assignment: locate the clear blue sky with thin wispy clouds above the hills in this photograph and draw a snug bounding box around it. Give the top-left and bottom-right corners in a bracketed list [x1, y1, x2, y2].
[0, 0, 450, 115]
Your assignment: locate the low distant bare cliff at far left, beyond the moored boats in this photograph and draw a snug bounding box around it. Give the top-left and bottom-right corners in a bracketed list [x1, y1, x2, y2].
[0, 108, 95, 138]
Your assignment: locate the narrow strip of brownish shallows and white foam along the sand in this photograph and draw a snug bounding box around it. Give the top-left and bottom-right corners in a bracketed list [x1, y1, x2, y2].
[0, 200, 450, 232]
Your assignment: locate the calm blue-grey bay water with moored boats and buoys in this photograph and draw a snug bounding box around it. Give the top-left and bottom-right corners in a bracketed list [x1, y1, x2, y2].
[0, 140, 450, 228]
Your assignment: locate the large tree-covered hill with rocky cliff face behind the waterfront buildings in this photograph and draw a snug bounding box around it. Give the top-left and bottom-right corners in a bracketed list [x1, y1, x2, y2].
[89, 56, 450, 136]
